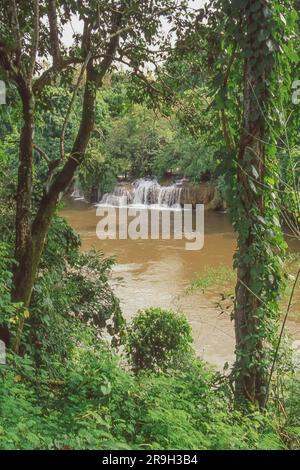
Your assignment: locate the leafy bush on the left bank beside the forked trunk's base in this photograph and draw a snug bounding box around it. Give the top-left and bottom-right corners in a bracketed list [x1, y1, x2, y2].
[24, 252, 125, 367]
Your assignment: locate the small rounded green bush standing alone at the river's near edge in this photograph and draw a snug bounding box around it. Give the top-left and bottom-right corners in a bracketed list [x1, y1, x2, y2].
[126, 308, 193, 372]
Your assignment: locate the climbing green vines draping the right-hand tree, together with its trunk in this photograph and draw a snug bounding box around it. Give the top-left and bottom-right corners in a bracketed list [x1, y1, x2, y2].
[213, 0, 297, 406]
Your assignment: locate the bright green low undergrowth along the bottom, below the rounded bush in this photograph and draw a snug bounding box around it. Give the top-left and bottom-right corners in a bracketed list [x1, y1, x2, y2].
[0, 342, 284, 450]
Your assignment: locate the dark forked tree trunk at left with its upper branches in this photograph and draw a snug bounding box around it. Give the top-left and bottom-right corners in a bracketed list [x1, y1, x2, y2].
[0, 6, 122, 351]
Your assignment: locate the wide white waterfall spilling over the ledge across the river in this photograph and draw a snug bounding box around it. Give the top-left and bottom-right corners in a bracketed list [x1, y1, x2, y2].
[99, 178, 182, 208]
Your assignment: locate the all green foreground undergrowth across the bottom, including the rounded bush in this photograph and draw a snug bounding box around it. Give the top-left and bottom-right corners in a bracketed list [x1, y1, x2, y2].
[0, 258, 300, 450]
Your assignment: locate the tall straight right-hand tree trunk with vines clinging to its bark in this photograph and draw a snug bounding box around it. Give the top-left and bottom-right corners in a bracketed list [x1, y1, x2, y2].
[234, 0, 280, 406]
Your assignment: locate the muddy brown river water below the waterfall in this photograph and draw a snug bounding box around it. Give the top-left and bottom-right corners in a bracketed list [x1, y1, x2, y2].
[62, 196, 300, 370]
